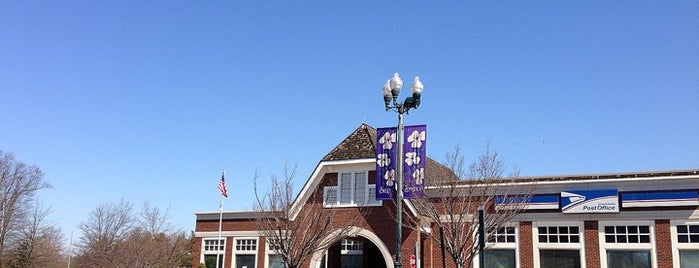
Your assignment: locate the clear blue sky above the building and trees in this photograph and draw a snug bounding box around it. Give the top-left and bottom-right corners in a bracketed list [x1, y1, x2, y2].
[0, 1, 699, 241]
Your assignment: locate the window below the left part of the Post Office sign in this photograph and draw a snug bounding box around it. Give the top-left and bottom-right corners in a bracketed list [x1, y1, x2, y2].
[534, 222, 585, 268]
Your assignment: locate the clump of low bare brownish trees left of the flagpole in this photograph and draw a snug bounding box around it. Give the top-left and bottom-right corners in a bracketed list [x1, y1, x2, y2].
[76, 199, 192, 267]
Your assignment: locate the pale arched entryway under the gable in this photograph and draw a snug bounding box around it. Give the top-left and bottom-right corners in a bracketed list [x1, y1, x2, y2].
[310, 227, 393, 268]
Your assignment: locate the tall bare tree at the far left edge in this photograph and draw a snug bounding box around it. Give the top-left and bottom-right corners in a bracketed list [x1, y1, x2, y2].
[0, 151, 50, 267]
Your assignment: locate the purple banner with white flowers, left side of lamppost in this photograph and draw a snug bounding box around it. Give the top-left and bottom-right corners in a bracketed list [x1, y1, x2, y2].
[375, 127, 398, 200]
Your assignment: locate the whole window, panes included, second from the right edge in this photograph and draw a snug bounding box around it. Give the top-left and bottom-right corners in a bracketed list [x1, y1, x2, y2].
[599, 221, 655, 268]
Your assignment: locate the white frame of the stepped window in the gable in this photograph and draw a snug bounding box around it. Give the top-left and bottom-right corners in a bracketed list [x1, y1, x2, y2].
[323, 170, 383, 208]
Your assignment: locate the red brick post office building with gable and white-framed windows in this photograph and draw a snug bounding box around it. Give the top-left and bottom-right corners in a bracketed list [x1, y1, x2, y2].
[193, 124, 699, 268]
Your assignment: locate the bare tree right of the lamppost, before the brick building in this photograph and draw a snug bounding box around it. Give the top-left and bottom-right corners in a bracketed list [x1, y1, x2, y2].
[413, 144, 531, 267]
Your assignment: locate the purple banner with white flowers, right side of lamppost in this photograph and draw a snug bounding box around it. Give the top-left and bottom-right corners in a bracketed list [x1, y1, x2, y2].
[403, 125, 427, 199]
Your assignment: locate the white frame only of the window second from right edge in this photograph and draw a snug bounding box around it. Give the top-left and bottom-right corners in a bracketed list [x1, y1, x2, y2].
[598, 221, 658, 268]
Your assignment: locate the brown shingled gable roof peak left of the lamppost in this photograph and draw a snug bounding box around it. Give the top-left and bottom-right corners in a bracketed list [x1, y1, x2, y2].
[320, 124, 376, 161]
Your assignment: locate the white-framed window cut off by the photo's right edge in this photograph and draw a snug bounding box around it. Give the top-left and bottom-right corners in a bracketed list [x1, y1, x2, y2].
[670, 220, 699, 268]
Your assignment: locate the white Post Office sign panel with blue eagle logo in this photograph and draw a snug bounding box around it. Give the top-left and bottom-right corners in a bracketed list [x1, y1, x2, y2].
[561, 189, 619, 213]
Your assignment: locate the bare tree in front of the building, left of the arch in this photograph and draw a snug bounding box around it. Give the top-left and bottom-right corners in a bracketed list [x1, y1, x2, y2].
[254, 163, 354, 268]
